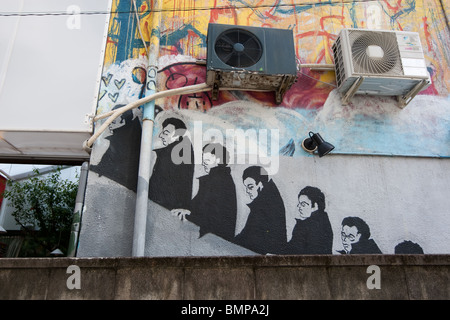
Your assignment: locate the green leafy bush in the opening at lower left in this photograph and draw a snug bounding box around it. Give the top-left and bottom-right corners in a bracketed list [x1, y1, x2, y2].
[3, 167, 78, 256]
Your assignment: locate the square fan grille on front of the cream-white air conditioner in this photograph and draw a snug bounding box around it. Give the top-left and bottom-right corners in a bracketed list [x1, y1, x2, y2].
[349, 31, 403, 75]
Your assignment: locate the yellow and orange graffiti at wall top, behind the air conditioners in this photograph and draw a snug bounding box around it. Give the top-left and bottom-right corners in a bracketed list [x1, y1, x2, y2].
[105, 0, 450, 95]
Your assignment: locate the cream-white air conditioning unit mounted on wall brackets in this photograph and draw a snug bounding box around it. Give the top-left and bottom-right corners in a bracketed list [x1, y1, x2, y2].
[332, 29, 431, 108]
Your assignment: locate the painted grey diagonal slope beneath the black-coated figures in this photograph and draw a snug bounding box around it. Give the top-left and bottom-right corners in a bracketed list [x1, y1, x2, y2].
[77, 172, 254, 257]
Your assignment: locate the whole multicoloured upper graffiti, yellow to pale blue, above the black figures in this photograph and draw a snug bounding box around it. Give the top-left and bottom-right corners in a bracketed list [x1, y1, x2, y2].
[97, 0, 450, 157]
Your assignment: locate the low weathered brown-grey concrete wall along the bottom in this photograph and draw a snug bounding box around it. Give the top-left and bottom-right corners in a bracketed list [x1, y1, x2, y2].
[0, 255, 450, 300]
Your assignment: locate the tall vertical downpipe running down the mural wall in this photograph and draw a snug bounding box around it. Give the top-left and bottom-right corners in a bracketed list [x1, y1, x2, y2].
[132, 0, 162, 257]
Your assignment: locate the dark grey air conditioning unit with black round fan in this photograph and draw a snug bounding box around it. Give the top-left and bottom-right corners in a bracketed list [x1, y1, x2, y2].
[206, 23, 297, 104]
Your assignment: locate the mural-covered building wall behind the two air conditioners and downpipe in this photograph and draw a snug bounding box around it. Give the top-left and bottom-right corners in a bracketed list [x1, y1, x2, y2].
[77, 0, 450, 257]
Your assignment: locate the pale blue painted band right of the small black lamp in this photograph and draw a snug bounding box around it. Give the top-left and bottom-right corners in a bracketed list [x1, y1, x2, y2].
[290, 106, 450, 158]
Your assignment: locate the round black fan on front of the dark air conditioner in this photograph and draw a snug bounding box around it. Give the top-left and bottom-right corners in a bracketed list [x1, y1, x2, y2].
[214, 29, 262, 68]
